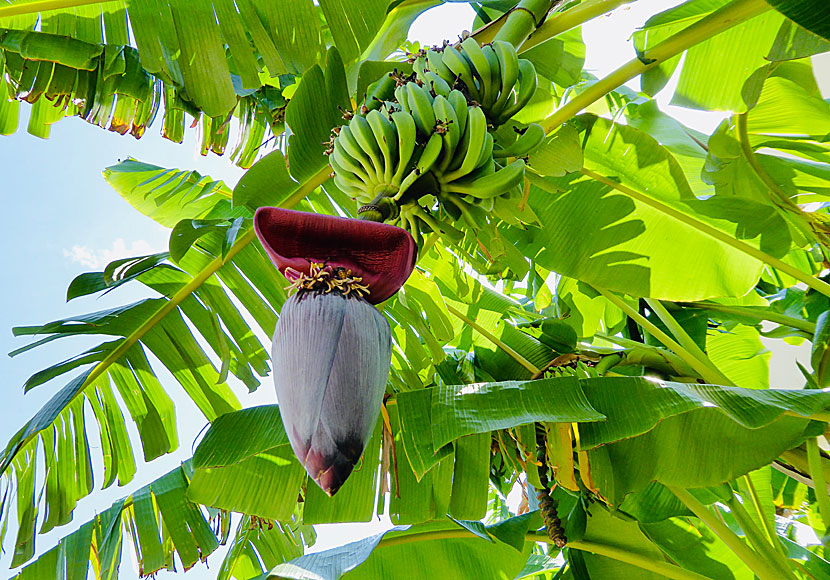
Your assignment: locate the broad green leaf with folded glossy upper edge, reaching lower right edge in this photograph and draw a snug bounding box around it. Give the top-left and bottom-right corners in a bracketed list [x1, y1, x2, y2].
[579, 378, 827, 504]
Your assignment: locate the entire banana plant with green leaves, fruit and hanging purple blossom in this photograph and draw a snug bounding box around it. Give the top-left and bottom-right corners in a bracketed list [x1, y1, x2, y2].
[0, 0, 830, 580]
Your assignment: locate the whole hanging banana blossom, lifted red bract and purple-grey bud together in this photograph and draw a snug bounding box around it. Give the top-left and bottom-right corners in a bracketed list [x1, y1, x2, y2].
[254, 208, 417, 495]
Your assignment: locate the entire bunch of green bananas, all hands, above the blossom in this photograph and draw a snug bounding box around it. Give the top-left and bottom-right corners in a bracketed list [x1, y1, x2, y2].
[329, 38, 545, 251]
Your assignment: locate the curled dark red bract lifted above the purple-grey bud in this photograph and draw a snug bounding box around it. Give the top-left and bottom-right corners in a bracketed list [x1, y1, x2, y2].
[254, 207, 417, 304]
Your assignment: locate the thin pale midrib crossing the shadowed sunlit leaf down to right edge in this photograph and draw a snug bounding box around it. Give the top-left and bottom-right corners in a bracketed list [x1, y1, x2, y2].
[581, 168, 830, 297]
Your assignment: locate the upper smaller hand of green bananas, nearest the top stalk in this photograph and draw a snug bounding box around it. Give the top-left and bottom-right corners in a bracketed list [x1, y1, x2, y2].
[413, 37, 537, 126]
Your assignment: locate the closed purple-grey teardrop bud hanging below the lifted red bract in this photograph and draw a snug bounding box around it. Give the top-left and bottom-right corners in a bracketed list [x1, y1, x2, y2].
[271, 290, 392, 495]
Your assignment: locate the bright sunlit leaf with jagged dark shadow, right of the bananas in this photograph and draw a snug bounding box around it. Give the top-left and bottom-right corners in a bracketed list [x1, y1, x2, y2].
[520, 119, 766, 300]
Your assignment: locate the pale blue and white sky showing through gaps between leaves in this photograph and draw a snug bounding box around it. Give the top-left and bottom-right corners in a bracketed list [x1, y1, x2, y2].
[0, 0, 824, 578]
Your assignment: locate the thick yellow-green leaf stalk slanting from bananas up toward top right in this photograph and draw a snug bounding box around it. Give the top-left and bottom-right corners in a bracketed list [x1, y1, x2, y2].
[540, 0, 770, 133]
